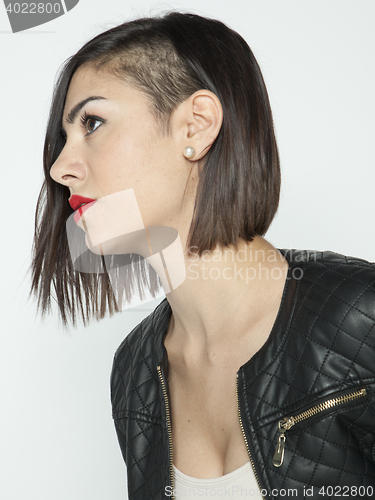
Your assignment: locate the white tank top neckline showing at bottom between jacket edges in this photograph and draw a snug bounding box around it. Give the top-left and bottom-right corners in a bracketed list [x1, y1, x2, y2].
[173, 462, 261, 500]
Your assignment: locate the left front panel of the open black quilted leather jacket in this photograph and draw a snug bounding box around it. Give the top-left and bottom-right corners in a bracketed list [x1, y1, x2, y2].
[111, 298, 169, 500]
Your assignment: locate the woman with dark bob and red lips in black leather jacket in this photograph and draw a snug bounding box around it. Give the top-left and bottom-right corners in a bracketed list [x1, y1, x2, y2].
[33, 12, 375, 500]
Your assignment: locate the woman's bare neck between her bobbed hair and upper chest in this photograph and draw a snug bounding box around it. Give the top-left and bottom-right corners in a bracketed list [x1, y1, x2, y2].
[166, 236, 288, 355]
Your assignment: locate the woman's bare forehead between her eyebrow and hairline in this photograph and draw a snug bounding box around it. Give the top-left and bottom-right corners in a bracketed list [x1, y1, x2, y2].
[63, 66, 147, 119]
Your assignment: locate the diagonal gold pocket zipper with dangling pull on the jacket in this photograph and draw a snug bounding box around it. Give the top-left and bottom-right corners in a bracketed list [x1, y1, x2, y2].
[273, 389, 367, 467]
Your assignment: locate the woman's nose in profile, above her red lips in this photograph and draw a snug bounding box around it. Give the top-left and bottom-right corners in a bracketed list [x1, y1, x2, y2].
[50, 143, 87, 187]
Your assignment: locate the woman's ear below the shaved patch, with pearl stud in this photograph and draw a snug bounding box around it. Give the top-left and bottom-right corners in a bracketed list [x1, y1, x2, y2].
[176, 89, 223, 161]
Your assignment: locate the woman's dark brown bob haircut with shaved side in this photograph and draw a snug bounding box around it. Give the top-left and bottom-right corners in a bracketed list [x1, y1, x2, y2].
[31, 11, 280, 325]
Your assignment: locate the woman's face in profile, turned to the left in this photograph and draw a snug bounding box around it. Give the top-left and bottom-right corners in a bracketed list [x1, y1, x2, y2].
[50, 67, 197, 253]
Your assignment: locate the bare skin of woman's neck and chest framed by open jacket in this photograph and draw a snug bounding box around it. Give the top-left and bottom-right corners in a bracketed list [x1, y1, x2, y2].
[165, 238, 288, 478]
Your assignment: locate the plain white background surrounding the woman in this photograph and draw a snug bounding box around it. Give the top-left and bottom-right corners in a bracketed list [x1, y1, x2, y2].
[0, 0, 375, 500]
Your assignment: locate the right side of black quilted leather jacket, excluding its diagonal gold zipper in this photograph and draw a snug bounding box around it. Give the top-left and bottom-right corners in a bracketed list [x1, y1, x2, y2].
[241, 253, 375, 498]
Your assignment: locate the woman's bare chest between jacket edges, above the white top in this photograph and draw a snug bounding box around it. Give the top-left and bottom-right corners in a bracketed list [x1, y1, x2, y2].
[169, 366, 249, 478]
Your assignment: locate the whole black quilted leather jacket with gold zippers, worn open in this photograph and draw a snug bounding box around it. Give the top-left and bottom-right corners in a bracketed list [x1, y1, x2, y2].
[111, 249, 375, 500]
